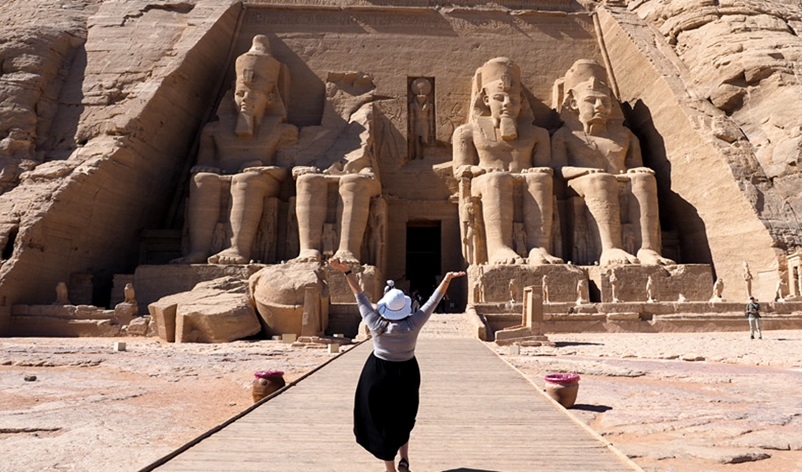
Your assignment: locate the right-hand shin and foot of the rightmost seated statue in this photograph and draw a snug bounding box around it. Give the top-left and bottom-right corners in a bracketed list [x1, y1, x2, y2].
[630, 173, 675, 265]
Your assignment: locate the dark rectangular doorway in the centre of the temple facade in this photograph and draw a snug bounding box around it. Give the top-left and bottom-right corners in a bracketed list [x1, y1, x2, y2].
[407, 221, 441, 300]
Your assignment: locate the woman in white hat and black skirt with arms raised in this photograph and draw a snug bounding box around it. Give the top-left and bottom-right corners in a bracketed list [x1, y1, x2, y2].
[329, 259, 465, 472]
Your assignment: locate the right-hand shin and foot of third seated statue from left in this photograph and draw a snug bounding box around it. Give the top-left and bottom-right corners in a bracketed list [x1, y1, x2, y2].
[522, 173, 563, 265]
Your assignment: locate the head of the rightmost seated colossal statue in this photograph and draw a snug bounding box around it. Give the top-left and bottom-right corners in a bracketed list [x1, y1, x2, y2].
[564, 59, 613, 125]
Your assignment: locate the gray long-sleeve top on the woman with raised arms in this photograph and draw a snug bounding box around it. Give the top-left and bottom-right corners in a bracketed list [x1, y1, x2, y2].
[356, 290, 443, 362]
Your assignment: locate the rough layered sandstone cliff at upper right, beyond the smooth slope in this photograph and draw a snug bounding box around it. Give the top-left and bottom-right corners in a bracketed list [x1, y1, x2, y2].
[608, 0, 802, 274]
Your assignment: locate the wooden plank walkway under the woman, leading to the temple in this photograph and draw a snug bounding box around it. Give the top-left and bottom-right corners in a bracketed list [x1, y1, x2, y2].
[143, 338, 640, 472]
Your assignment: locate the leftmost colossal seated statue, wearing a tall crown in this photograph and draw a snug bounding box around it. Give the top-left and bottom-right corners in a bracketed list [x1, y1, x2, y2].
[172, 35, 298, 264]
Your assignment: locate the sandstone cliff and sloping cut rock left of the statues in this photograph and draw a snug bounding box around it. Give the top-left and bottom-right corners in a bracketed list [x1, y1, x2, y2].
[0, 1, 241, 331]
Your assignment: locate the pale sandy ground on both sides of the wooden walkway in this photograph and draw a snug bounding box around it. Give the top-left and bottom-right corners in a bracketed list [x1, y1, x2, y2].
[0, 314, 802, 472]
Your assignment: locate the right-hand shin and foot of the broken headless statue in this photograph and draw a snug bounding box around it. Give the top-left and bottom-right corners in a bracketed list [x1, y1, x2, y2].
[335, 174, 381, 263]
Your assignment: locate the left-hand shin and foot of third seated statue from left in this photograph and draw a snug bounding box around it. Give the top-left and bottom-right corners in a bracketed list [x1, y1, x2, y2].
[474, 172, 524, 264]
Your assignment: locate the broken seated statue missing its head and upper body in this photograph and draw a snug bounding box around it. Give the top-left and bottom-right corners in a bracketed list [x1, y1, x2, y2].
[292, 73, 386, 264]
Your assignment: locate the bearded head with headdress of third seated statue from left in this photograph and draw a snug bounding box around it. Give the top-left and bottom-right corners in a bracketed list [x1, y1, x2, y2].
[471, 57, 528, 140]
